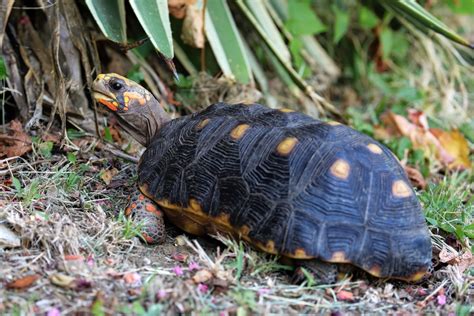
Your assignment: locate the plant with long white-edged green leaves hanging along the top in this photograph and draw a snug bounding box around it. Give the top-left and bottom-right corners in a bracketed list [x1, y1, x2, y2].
[86, 0, 472, 115]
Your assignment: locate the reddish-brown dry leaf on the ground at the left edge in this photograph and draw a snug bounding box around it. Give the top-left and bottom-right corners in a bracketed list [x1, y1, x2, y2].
[0, 120, 31, 158]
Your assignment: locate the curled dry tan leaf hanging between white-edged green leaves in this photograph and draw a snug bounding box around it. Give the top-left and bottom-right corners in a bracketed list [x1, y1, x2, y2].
[181, 5, 206, 48]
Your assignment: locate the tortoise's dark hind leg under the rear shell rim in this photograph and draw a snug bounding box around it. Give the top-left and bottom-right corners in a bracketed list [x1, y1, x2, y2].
[292, 260, 338, 284]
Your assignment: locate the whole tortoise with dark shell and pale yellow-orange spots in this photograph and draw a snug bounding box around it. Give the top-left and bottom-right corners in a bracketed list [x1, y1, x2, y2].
[92, 73, 432, 282]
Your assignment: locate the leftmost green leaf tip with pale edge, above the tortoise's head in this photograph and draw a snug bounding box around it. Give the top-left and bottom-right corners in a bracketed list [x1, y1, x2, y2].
[86, 0, 127, 43]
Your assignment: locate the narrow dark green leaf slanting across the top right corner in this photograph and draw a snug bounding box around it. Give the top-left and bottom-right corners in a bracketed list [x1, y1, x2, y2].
[383, 0, 474, 48]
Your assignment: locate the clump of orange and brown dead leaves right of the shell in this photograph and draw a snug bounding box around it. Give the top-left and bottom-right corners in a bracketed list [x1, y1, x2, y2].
[375, 109, 471, 170]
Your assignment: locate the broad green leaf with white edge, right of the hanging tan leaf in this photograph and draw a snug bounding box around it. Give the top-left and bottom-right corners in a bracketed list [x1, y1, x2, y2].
[205, 0, 253, 83]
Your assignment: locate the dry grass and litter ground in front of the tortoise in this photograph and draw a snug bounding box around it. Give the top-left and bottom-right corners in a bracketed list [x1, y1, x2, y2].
[0, 139, 474, 315]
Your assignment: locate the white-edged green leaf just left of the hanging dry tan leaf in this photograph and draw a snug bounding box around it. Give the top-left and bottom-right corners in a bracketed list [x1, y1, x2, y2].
[130, 0, 174, 59]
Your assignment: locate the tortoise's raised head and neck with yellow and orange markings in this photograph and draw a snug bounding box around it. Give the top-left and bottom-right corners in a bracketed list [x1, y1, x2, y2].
[92, 73, 170, 146]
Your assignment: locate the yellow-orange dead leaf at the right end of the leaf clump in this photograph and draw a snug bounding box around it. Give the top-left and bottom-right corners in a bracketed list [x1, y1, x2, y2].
[430, 128, 471, 170]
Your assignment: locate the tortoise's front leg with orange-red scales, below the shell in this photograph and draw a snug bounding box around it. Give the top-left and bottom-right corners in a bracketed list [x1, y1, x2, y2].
[125, 190, 166, 244]
